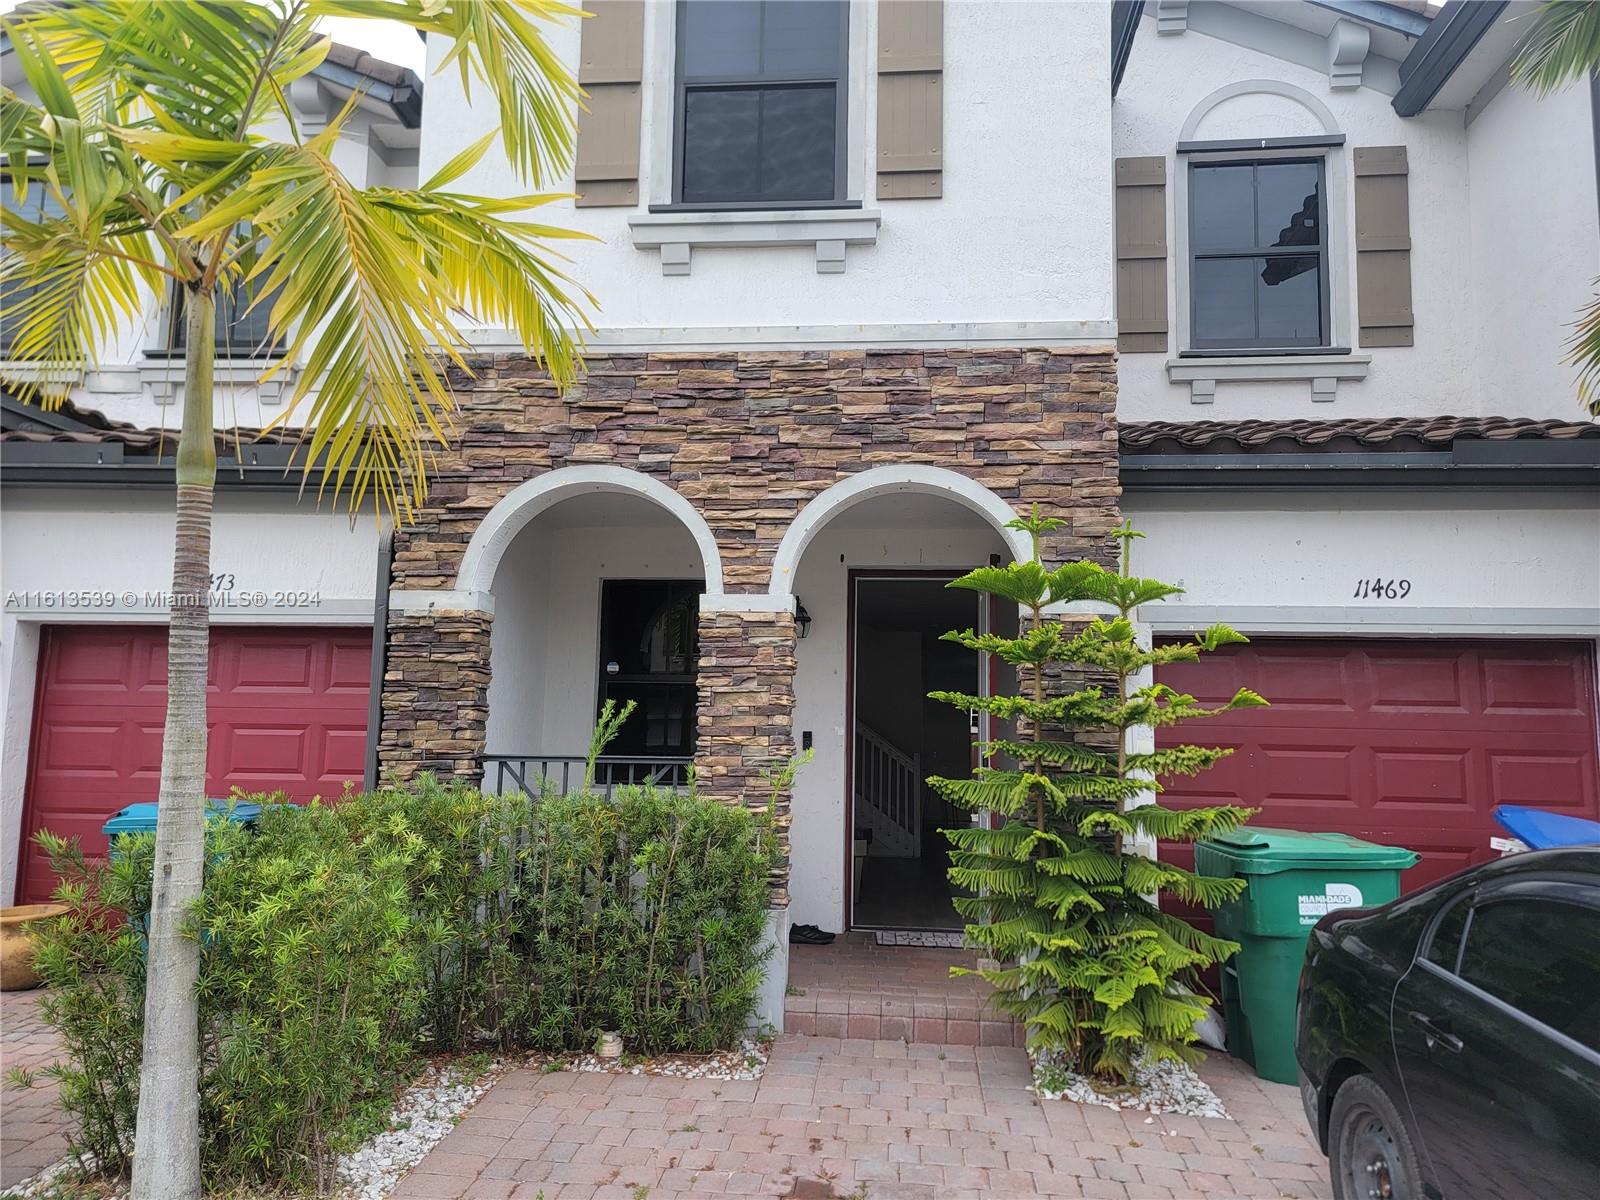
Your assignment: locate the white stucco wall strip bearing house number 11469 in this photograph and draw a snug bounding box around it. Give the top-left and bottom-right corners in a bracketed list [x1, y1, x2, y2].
[1122, 488, 1600, 637]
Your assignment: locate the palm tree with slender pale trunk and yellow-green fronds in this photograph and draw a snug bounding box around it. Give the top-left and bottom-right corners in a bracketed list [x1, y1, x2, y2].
[0, 0, 592, 1200]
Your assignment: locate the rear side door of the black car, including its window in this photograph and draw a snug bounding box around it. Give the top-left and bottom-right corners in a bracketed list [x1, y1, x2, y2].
[1394, 882, 1600, 1200]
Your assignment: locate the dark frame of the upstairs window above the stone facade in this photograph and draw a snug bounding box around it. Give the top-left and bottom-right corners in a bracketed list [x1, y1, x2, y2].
[672, 0, 851, 213]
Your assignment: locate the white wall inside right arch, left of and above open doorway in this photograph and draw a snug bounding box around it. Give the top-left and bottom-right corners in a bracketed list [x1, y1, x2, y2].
[789, 512, 1010, 930]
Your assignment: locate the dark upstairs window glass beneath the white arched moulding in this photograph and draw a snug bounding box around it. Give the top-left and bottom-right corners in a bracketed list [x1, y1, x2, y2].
[1189, 158, 1328, 350]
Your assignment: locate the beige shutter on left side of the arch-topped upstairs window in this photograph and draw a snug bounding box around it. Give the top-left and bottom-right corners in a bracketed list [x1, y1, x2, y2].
[1117, 155, 1166, 354]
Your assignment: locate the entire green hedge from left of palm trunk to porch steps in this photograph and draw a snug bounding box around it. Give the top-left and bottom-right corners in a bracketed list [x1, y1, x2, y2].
[25, 778, 773, 1189]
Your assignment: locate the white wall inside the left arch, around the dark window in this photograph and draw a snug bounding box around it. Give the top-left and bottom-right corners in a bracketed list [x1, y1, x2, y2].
[488, 498, 704, 755]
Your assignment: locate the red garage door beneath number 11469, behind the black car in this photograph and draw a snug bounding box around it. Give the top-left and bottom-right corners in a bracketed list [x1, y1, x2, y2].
[1158, 638, 1600, 890]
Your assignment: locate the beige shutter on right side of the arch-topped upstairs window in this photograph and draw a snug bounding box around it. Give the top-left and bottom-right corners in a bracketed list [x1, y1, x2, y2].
[1355, 146, 1414, 346]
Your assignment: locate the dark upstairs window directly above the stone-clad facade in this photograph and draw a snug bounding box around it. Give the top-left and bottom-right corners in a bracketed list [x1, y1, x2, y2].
[674, 0, 848, 208]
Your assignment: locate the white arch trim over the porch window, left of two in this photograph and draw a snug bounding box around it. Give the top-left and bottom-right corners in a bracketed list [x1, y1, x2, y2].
[456, 466, 722, 595]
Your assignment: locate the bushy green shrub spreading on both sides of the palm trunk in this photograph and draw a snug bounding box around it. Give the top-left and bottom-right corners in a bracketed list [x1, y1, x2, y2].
[38, 805, 429, 1187]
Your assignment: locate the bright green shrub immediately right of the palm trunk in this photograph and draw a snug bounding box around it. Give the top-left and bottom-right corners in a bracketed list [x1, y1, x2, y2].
[195, 805, 429, 1190]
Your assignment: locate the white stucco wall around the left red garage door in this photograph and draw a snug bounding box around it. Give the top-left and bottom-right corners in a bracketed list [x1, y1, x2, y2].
[0, 488, 378, 902]
